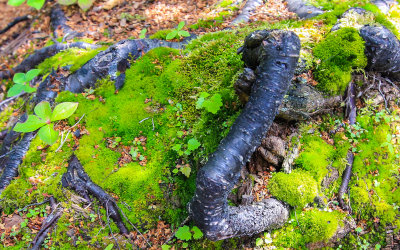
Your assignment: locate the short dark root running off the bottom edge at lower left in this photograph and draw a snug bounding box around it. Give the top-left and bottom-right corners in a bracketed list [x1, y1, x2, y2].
[30, 197, 64, 250]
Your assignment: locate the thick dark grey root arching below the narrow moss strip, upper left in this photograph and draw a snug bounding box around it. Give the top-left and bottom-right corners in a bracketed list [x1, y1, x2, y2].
[65, 39, 189, 93]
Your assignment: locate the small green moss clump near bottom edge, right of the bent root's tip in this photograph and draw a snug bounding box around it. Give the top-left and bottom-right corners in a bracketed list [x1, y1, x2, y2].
[299, 209, 339, 242]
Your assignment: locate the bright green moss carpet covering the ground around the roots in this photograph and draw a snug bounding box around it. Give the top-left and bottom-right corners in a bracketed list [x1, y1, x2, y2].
[0, 1, 400, 249]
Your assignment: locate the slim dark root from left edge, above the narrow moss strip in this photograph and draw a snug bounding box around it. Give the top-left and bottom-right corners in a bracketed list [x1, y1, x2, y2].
[0, 42, 101, 80]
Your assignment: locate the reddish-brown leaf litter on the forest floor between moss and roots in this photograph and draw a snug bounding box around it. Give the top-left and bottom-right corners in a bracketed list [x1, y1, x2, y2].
[0, 0, 400, 249]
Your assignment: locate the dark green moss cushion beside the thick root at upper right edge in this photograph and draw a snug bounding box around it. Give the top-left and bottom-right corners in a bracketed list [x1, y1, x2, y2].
[313, 28, 367, 95]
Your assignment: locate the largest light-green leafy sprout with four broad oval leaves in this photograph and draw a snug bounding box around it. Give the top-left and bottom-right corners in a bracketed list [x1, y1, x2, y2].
[14, 101, 78, 145]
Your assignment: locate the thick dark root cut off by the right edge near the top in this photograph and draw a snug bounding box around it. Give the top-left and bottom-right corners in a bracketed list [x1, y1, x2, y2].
[360, 25, 400, 81]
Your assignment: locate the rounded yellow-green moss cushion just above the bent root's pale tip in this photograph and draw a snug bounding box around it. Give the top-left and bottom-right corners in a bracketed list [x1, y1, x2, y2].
[268, 170, 318, 208]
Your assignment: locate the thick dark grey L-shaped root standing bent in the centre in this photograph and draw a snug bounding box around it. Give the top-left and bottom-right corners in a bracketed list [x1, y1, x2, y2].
[188, 30, 300, 241]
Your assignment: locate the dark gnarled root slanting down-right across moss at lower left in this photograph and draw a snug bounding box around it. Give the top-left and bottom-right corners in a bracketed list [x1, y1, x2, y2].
[61, 155, 129, 234]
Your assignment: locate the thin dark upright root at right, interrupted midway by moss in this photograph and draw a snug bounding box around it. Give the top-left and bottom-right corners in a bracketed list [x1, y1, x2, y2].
[338, 81, 357, 212]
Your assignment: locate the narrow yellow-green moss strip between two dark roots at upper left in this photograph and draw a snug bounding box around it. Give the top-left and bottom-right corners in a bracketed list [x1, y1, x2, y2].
[37, 47, 105, 74]
